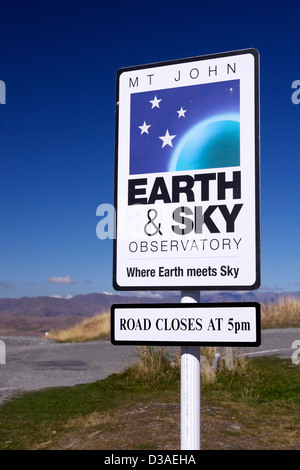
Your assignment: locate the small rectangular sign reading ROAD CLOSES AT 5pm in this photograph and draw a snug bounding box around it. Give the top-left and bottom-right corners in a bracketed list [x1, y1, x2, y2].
[111, 302, 261, 346]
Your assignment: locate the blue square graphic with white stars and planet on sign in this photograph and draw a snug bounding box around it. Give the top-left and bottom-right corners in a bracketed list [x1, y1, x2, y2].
[130, 80, 240, 175]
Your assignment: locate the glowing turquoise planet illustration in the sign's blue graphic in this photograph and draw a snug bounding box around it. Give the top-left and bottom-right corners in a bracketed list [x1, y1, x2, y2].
[170, 114, 240, 171]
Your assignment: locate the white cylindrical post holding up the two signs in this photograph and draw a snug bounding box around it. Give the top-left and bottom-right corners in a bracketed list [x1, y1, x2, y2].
[181, 291, 200, 450]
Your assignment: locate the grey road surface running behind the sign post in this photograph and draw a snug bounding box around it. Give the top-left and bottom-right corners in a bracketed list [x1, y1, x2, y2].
[0, 328, 300, 404]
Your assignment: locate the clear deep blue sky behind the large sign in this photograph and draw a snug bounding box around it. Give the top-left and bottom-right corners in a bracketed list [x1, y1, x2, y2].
[0, 0, 300, 297]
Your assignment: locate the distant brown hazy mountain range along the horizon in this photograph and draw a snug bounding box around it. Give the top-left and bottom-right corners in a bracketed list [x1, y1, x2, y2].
[0, 291, 300, 336]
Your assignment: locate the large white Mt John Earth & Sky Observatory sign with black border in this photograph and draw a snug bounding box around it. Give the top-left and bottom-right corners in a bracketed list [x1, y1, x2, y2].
[113, 49, 260, 290]
